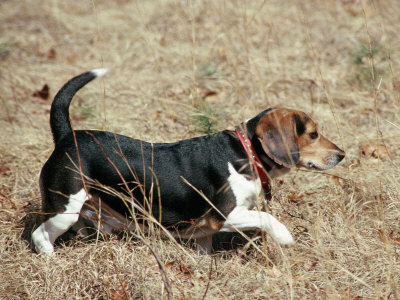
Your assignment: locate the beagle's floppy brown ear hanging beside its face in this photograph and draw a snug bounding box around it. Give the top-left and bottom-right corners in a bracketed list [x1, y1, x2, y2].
[256, 109, 300, 168]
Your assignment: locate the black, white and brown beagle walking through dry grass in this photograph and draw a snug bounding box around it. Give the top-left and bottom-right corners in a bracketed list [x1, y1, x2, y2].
[32, 69, 345, 254]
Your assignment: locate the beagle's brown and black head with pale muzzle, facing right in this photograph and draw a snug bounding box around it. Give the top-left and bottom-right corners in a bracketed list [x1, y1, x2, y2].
[256, 108, 345, 170]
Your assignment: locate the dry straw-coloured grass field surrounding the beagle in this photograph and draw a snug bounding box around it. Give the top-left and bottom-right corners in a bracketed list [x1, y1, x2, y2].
[0, 0, 400, 299]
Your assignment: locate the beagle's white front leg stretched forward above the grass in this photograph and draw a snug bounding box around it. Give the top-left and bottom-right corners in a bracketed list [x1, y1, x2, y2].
[220, 206, 294, 245]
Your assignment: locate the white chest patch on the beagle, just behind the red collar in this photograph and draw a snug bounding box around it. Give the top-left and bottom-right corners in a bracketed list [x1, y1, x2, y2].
[228, 163, 261, 209]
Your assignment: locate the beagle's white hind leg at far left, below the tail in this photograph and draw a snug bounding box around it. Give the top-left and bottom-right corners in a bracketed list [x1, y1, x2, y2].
[32, 189, 88, 255]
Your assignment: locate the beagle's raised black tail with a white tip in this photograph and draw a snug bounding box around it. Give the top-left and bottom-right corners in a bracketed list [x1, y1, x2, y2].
[50, 69, 108, 144]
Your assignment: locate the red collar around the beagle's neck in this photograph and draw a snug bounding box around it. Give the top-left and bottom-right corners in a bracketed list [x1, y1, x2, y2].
[235, 128, 271, 201]
